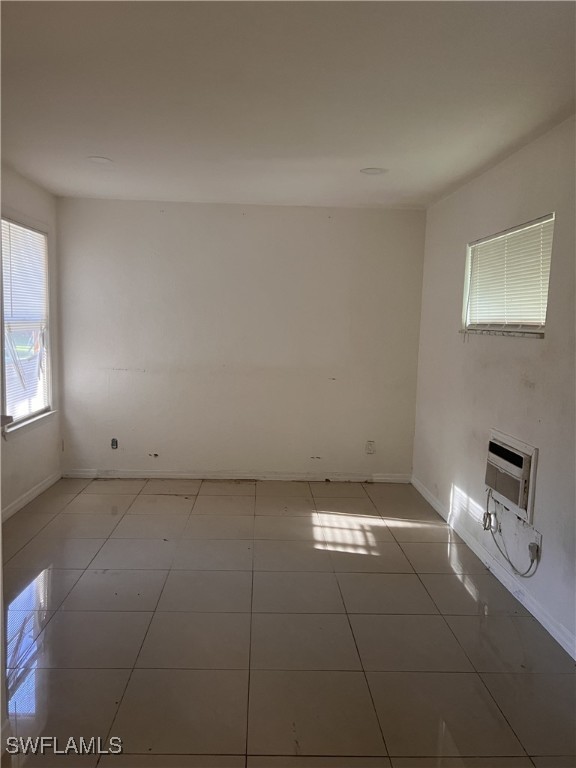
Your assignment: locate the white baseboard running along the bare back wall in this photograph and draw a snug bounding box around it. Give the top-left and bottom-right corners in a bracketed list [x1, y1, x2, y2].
[63, 469, 410, 483]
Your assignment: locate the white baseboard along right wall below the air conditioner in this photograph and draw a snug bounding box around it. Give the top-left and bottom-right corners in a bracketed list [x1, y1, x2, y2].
[412, 477, 576, 659]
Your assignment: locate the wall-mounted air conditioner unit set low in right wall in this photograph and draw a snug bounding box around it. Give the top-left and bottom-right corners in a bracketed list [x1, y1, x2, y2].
[485, 429, 538, 523]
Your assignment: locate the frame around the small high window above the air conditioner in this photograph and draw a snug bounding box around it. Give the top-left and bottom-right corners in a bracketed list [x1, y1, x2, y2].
[460, 212, 556, 339]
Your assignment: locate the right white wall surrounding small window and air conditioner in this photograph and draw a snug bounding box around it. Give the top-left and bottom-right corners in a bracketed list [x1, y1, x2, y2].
[414, 120, 576, 654]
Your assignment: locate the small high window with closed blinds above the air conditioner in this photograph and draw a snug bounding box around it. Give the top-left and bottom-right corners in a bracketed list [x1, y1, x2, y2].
[464, 214, 554, 336]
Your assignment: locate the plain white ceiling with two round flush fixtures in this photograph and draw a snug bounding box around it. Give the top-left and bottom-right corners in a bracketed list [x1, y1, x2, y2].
[2, 0, 575, 207]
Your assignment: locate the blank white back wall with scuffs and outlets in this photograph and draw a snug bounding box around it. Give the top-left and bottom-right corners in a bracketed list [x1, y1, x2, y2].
[58, 199, 424, 481]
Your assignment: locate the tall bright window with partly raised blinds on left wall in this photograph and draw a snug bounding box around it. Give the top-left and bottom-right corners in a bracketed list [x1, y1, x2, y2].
[2, 219, 50, 423]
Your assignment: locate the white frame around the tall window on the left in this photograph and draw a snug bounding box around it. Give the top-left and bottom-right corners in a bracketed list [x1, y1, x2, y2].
[0, 213, 55, 428]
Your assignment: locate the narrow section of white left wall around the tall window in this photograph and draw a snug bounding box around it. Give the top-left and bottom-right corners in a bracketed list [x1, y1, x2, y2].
[2, 167, 61, 518]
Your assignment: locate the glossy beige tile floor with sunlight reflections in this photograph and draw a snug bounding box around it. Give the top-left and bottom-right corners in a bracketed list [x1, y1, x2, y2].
[2, 480, 576, 768]
